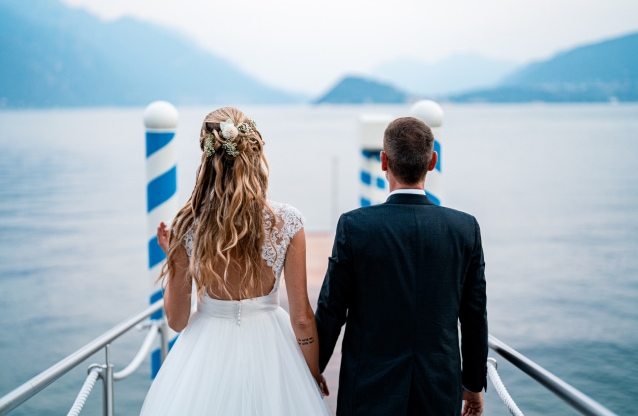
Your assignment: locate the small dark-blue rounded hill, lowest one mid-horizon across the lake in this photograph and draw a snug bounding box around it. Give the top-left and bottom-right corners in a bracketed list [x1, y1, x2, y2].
[315, 76, 408, 104]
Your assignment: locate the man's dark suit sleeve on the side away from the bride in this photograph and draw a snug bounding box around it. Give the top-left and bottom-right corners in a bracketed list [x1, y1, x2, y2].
[459, 219, 488, 392]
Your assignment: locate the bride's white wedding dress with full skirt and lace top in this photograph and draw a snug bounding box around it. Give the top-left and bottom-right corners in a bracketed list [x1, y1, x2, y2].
[141, 202, 330, 416]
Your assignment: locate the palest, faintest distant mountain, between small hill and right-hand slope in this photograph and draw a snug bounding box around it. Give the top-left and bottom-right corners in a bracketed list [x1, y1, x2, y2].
[370, 53, 517, 96]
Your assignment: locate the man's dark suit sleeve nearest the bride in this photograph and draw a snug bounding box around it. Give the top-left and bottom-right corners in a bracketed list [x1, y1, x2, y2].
[315, 215, 354, 373]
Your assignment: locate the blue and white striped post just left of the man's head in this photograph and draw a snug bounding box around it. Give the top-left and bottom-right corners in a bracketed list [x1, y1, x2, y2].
[359, 115, 392, 207]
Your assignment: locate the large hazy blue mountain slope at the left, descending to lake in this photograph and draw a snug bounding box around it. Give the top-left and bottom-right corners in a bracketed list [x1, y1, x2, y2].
[0, 0, 302, 107]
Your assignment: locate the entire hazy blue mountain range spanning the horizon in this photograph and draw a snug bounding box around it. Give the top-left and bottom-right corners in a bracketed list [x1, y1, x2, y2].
[0, 0, 638, 108]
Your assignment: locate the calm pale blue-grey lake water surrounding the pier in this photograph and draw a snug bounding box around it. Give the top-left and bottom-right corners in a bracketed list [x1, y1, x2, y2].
[0, 104, 638, 415]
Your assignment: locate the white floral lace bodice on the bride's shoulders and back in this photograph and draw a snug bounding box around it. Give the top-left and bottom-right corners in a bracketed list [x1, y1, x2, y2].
[184, 201, 306, 293]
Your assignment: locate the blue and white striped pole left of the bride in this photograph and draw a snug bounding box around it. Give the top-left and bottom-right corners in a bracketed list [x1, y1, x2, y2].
[144, 101, 178, 377]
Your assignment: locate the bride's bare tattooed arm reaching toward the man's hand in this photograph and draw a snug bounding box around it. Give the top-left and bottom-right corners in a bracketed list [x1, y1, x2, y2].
[284, 228, 326, 393]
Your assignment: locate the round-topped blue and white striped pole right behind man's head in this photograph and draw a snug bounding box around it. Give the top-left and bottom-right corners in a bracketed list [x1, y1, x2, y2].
[410, 100, 443, 205]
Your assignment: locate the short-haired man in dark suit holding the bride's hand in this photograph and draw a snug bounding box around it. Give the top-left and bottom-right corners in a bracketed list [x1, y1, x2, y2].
[315, 117, 487, 416]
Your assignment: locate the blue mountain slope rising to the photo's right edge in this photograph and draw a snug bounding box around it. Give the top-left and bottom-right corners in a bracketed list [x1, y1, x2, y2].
[450, 33, 638, 102]
